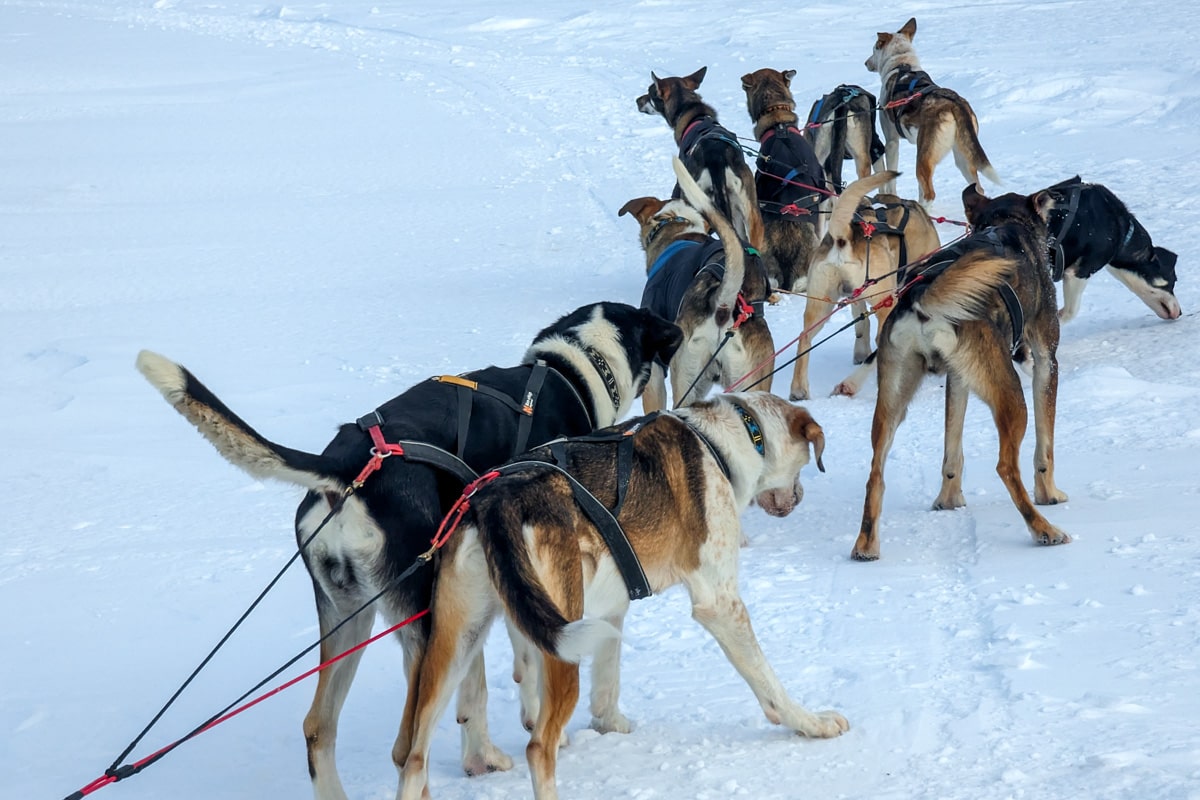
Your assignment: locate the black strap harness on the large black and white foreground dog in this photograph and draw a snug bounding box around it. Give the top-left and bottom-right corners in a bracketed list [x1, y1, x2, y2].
[354, 359, 600, 488]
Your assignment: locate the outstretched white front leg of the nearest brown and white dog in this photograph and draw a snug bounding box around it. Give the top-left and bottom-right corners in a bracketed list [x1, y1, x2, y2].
[689, 581, 850, 739]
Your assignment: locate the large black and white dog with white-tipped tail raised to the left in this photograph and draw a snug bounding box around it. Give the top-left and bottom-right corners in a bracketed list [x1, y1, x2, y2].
[137, 302, 683, 800]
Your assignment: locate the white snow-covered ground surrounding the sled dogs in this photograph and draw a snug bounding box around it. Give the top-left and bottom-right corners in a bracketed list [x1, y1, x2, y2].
[0, 0, 1200, 800]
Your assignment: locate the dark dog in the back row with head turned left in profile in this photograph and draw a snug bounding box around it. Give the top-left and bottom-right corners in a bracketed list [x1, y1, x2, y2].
[637, 67, 766, 252]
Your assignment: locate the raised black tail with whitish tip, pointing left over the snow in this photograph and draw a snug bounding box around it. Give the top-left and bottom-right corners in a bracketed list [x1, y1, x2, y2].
[137, 350, 344, 492]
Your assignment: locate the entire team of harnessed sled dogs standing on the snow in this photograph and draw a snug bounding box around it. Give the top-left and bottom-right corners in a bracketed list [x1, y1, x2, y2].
[137, 19, 1181, 800]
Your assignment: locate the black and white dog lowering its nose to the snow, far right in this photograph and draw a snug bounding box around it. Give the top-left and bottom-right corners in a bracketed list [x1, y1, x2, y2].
[1045, 175, 1182, 323]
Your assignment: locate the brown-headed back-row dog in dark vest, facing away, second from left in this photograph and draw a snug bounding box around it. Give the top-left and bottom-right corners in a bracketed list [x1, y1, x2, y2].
[742, 68, 825, 291]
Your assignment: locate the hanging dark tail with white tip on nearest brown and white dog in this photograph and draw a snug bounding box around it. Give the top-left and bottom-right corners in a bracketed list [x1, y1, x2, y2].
[473, 489, 620, 662]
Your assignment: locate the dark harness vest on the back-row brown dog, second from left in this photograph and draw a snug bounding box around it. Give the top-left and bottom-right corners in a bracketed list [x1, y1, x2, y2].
[755, 124, 826, 223]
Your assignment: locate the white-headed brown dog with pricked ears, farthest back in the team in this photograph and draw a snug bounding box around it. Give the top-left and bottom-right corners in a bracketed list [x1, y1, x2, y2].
[866, 19, 1000, 207]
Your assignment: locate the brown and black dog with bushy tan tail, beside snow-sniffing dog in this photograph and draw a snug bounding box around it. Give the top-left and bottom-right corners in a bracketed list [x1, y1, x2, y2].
[851, 186, 1070, 561]
